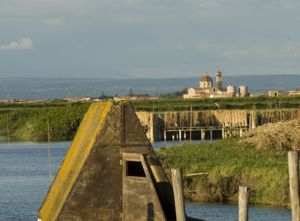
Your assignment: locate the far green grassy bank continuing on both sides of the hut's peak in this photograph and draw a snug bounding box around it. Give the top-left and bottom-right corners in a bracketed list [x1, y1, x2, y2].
[0, 96, 300, 140]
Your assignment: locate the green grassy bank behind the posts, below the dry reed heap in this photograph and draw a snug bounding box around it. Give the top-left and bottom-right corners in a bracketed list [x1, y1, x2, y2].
[158, 138, 289, 206]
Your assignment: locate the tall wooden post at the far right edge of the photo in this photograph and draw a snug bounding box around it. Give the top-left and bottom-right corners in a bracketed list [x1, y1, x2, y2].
[288, 151, 300, 221]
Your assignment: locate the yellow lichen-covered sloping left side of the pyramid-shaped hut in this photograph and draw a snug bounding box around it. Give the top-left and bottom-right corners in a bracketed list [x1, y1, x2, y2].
[39, 103, 112, 220]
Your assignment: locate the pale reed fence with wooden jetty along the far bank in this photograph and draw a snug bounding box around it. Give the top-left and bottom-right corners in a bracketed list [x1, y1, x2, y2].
[137, 108, 300, 141]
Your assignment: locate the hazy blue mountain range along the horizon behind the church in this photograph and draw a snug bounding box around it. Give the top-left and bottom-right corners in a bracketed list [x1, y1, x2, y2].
[0, 75, 300, 99]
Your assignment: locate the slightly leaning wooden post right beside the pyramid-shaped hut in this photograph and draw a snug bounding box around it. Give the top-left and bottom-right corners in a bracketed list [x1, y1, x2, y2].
[171, 169, 186, 221]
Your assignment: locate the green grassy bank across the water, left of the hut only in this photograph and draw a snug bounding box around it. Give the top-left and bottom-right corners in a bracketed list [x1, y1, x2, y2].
[0, 102, 89, 141]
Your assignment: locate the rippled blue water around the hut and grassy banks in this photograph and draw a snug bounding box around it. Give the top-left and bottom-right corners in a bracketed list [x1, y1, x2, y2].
[0, 142, 291, 221]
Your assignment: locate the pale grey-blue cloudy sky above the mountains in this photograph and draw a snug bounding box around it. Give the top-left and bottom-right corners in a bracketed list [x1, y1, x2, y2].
[0, 0, 300, 78]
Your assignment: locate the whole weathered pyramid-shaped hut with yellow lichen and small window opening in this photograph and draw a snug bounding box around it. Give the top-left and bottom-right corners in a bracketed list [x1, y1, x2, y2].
[38, 102, 199, 221]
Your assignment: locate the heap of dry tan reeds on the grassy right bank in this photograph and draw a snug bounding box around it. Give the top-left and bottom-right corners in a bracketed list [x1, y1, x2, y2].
[240, 119, 300, 151]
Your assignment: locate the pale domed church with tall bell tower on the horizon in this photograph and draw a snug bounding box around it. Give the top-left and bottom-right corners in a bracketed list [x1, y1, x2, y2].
[183, 70, 249, 99]
